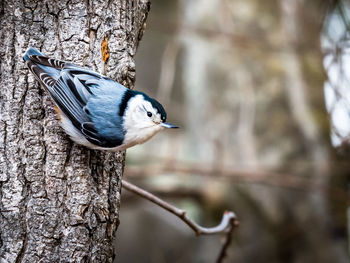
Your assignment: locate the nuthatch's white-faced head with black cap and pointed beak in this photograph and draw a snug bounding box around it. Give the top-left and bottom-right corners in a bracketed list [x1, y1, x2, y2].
[124, 92, 178, 144]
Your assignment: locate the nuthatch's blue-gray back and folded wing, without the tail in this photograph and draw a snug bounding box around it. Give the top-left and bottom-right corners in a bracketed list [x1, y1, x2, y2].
[47, 64, 126, 148]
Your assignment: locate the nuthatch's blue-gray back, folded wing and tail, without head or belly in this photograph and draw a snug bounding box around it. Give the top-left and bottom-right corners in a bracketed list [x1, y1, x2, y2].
[23, 48, 127, 148]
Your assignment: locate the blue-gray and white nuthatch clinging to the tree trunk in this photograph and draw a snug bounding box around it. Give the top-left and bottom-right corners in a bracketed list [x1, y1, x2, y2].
[23, 47, 178, 151]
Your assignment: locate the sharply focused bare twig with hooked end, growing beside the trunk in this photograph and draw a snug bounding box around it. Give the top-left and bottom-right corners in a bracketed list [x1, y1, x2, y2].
[122, 180, 238, 263]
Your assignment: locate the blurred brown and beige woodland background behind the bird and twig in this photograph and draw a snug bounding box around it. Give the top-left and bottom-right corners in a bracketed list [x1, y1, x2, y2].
[117, 0, 350, 263]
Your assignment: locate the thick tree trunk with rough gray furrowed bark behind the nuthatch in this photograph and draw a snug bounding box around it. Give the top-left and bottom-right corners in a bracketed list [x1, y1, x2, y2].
[0, 0, 149, 263]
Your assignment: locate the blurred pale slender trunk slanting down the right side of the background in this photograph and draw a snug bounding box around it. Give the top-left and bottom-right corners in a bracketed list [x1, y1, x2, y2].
[280, 0, 325, 168]
